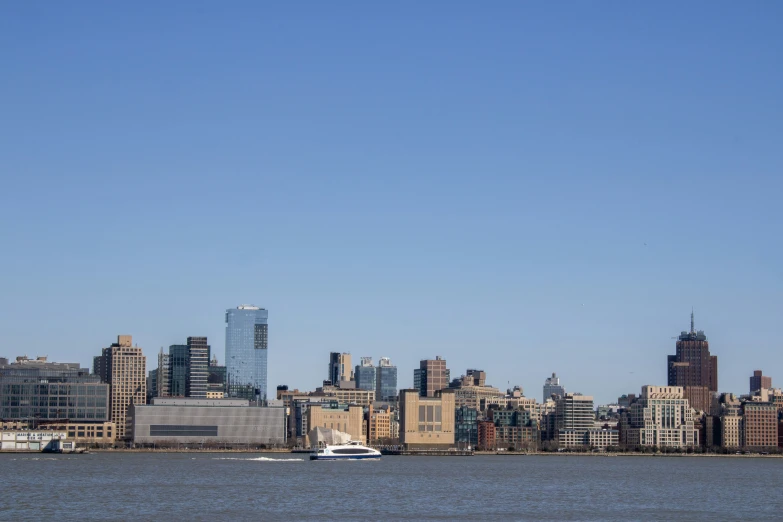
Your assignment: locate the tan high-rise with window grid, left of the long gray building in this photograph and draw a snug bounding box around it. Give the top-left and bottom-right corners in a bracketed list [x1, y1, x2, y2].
[95, 335, 147, 440]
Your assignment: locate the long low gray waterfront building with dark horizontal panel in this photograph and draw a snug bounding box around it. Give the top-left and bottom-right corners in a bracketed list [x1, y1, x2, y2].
[126, 399, 286, 445]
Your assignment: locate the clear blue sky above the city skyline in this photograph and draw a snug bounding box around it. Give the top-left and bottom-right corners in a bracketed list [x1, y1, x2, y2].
[0, 1, 783, 402]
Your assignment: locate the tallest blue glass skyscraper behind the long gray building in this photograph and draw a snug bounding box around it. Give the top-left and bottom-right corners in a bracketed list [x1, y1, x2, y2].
[226, 305, 269, 401]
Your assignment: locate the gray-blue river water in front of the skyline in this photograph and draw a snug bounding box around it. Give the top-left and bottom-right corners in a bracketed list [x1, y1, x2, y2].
[0, 453, 783, 522]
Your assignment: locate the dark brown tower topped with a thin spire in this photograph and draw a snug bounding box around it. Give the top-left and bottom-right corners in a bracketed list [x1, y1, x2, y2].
[668, 312, 718, 412]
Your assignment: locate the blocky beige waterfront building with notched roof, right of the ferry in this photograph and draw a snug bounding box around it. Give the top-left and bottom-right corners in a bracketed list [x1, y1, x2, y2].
[400, 389, 455, 449]
